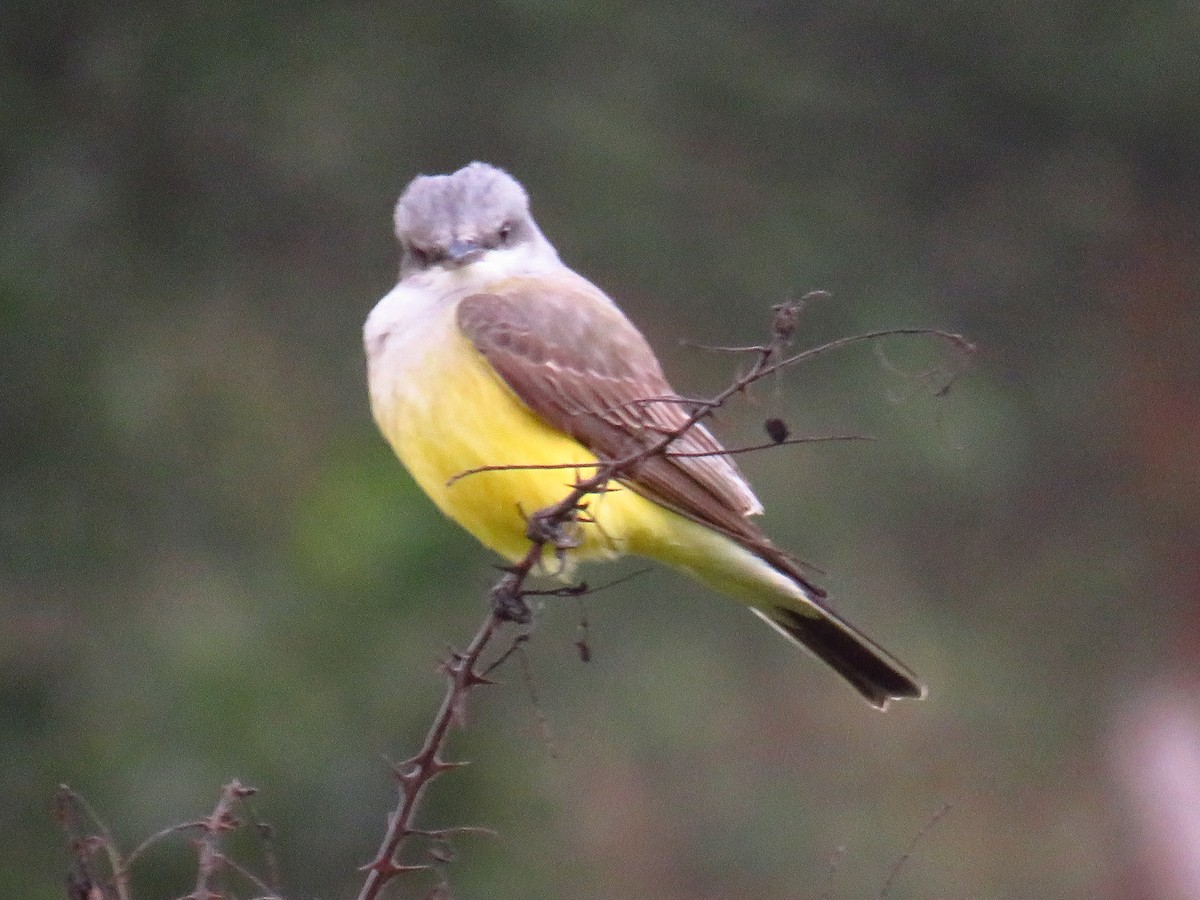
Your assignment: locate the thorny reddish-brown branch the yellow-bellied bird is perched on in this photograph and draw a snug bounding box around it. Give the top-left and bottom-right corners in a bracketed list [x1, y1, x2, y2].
[359, 292, 976, 900]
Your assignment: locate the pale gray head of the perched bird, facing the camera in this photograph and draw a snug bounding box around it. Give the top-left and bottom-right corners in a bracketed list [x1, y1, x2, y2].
[396, 162, 557, 277]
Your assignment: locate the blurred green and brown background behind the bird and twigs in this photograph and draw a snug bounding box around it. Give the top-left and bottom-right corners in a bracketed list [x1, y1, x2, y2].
[0, 0, 1200, 900]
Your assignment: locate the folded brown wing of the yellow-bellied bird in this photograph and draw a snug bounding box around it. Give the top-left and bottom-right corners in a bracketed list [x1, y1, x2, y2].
[457, 278, 816, 574]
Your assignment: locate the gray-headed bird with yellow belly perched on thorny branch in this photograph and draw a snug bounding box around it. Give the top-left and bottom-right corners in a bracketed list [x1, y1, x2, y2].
[364, 162, 924, 709]
